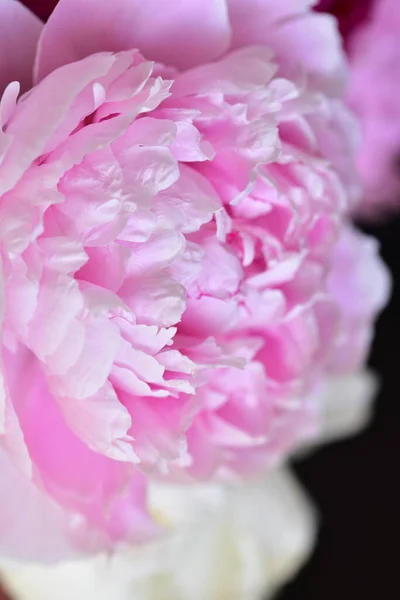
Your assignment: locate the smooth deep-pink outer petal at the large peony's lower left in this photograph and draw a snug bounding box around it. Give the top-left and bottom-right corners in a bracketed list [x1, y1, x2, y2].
[7, 363, 155, 551]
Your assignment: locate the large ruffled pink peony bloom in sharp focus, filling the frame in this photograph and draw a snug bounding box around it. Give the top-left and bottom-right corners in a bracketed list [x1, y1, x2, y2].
[0, 0, 388, 560]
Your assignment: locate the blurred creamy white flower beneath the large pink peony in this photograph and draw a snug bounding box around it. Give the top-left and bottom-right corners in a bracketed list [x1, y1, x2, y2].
[3, 469, 315, 600]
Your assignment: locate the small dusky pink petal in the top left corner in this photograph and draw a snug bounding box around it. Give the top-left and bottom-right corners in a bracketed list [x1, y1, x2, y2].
[0, 0, 43, 96]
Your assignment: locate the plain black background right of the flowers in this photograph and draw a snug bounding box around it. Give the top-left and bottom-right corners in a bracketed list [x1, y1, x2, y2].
[279, 220, 400, 600]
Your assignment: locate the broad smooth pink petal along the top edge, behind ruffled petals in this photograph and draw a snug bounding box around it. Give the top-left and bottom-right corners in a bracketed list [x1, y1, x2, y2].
[37, 0, 230, 80]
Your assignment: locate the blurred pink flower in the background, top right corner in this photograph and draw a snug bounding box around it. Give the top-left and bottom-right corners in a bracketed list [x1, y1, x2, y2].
[321, 0, 400, 216]
